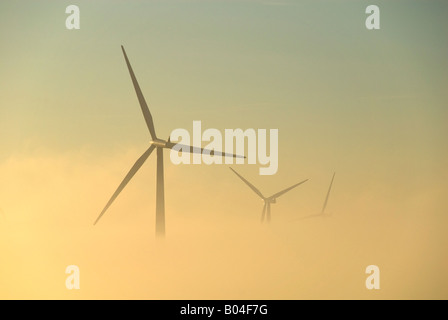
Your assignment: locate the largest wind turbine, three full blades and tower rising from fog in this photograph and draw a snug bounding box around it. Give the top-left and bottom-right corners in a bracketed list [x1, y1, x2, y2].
[94, 46, 245, 236]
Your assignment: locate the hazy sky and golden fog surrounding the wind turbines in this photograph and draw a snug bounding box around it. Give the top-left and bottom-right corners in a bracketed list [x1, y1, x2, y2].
[0, 0, 448, 299]
